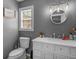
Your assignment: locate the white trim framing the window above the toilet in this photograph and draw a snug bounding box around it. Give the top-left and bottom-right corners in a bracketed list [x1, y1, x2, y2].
[19, 5, 34, 31]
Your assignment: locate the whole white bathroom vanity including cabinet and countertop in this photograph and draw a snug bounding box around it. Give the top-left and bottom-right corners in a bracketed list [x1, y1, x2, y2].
[33, 37, 76, 59]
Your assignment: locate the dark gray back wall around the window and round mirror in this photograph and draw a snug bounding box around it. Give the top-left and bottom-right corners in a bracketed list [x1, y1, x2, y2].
[19, 0, 76, 51]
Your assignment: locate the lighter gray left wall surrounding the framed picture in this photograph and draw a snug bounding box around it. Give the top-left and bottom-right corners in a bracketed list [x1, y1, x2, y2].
[3, 0, 18, 59]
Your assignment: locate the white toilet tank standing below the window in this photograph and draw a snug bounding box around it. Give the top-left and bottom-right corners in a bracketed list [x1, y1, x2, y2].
[20, 37, 30, 49]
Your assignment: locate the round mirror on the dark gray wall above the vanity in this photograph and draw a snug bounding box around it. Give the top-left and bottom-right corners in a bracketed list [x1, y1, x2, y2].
[51, 10, 67, 24]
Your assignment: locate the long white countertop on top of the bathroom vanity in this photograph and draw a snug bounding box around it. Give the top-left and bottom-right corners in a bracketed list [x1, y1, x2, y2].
[33, 37, 76, 47]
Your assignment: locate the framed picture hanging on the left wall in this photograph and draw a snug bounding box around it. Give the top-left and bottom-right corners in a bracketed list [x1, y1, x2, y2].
[3, 8, 16, 18]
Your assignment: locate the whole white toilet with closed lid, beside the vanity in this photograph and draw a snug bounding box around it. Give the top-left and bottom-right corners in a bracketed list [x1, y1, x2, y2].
[7, 37, 30, 59]
